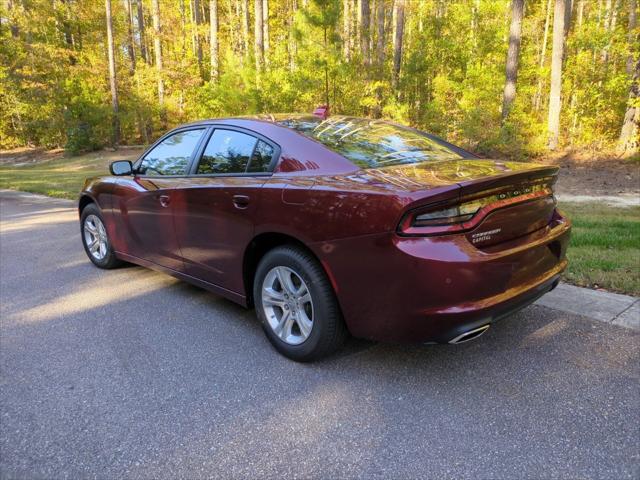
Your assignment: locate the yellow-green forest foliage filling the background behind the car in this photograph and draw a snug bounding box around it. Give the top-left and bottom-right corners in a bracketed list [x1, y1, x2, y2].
[0, 0, 639, 158]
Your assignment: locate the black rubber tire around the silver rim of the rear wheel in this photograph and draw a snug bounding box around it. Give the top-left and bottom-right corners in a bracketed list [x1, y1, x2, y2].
[253, 246, 347, 362]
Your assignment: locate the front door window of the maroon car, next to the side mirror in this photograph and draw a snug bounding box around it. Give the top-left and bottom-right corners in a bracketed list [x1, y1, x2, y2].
[138, 128, 205, 176]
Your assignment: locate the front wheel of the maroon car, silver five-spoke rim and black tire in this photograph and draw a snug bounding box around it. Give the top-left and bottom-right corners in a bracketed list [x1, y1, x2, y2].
[80, 203, 122, 269]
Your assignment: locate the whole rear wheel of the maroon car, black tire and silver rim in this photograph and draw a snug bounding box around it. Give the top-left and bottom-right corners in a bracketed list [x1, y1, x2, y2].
[253, 246, 347, 362]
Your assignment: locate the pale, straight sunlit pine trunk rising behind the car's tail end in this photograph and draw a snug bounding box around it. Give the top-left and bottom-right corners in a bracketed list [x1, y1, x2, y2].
[548, 0, 567, 150]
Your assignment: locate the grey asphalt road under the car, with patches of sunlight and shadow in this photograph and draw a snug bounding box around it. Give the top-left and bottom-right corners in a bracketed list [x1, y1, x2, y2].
[0, 189, 640, 479]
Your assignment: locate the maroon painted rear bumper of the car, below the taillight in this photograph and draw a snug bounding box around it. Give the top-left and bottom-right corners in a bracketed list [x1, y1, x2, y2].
[315, 219, 571, 343]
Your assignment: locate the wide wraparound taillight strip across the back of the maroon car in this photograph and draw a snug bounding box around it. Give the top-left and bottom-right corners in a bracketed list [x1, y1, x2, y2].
[398, 182, 555, 235]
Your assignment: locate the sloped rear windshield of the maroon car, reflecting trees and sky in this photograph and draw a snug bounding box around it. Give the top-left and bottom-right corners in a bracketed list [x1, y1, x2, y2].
[277, 116, 464, 168]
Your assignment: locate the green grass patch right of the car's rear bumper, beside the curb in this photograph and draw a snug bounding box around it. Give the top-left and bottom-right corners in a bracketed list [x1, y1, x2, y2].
[560, 203, 640, 295]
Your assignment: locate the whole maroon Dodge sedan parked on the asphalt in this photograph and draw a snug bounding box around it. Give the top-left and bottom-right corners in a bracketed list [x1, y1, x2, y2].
[79, 115, 571, 361]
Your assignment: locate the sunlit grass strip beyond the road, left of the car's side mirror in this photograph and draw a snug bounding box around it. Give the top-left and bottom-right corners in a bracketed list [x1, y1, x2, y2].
[0, 149, 140, 199]
